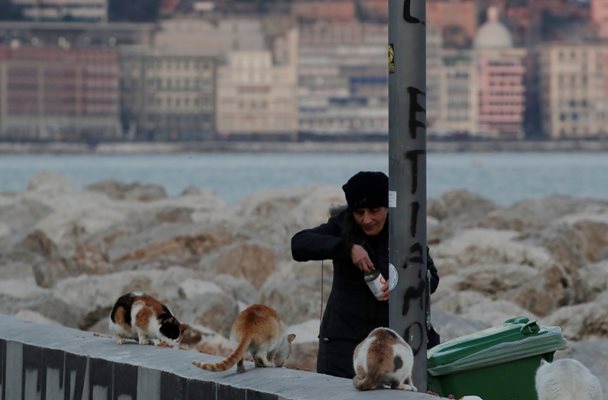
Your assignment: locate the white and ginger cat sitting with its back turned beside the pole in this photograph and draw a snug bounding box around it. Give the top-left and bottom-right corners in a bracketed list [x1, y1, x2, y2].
[353, 328, 417, 392]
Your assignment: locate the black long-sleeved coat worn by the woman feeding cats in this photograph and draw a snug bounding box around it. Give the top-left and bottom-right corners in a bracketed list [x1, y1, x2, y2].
[291, 209, 439, 376]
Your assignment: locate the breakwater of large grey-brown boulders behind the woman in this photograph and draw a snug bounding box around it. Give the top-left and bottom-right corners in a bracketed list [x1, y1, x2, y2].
[0, 172, 608, 393]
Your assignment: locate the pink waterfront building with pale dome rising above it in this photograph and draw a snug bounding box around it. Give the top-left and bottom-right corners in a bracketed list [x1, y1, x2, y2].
[474, 7, 526, 139]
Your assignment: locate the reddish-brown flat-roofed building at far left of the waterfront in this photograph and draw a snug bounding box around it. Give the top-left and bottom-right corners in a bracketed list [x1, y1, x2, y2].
[0, 45, 121, 140]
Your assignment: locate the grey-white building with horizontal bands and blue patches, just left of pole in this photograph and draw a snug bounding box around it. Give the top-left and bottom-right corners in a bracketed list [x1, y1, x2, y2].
[298, 22, 388, 139]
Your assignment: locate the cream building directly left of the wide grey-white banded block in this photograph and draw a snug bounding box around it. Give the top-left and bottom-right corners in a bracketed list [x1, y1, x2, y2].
[216, 25, 298, 140]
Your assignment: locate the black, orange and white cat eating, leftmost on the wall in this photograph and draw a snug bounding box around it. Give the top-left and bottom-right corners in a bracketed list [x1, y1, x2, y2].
[109, 292, 188, 345]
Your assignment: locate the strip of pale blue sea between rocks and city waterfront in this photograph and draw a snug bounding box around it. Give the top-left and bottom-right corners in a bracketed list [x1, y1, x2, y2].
[0, 152, 608, 206]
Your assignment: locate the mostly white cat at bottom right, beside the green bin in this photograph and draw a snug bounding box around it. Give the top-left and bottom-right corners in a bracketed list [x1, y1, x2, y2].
[535, 358, 602, 400]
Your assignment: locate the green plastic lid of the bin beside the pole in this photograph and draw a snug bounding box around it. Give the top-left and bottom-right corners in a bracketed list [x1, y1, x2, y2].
[427, 317, 568, 376]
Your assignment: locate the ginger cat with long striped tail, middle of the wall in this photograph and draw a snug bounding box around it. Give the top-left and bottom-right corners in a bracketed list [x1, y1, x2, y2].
[192, 304, 296, 372]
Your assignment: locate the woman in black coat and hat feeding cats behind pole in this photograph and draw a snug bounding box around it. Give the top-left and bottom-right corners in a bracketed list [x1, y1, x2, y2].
[291, 171, 439, 378]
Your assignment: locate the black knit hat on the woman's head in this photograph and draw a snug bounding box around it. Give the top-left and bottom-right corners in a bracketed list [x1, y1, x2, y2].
[342, 171, 388, 210]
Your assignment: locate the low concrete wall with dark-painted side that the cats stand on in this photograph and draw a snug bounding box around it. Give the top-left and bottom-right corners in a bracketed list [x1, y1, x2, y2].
[0, 315, 438, 400]
